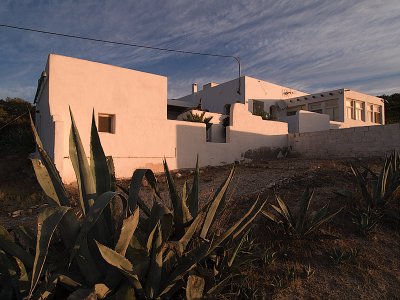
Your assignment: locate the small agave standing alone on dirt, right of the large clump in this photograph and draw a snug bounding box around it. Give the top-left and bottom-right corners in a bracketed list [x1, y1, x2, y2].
[262, 188, 343, 239]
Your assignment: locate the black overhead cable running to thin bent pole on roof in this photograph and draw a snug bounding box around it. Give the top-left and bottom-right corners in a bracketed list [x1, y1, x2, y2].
[0, 24, 241, 94]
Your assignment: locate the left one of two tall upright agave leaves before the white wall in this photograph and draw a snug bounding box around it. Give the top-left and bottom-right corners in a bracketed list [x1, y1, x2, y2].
[69, 108, 96, 214]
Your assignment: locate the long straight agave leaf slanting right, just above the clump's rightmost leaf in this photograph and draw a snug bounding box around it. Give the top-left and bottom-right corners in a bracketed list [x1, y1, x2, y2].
[200, 167, 235, 239]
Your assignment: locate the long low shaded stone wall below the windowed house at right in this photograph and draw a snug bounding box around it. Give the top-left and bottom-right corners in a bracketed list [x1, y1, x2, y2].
[289, 124, 400, 158]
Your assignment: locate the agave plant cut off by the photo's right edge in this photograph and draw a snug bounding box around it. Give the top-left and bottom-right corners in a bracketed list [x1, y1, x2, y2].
[350, 152, 400, 209]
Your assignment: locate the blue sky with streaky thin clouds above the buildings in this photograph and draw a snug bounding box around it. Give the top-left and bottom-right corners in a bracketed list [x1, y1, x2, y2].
[0, 0, 400, 101]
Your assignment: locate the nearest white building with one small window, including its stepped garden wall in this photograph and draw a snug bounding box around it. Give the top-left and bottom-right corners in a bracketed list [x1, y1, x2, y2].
[35, 54, 288, 182]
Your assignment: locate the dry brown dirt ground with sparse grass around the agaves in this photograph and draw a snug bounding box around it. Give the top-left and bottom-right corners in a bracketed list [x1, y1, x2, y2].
[0, 156, 400, 299]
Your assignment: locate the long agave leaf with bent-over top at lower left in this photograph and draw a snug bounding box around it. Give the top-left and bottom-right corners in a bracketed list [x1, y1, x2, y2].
[29, 206, 70, 296]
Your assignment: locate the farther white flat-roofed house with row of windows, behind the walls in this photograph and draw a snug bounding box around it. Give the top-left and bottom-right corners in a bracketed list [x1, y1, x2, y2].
[173, 76, 385, 132]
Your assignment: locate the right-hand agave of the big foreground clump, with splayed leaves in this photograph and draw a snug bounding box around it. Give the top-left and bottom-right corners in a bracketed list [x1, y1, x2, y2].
[98, 161, 265, 299]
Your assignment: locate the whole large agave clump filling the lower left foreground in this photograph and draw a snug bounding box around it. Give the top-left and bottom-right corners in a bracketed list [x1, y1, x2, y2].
[0, 109, 264, 299]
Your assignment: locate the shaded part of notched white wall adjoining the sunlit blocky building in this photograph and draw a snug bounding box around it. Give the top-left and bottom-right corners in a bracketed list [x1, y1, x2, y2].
[176, 125, 288, 169]
